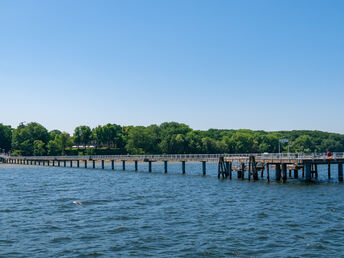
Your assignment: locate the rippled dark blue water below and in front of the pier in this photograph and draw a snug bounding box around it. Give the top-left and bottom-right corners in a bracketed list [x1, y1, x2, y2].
[0, 163, 344, 257]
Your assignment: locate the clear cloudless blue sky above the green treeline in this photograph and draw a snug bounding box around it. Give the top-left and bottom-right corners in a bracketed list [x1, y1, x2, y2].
[0, 0, 344, 133]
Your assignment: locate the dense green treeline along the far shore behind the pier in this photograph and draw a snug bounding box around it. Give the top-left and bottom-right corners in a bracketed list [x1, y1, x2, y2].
[0, 122, 344, 156]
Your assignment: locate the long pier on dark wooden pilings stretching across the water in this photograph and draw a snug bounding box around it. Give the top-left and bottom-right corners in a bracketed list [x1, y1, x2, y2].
[0, 152, 344, 182]
